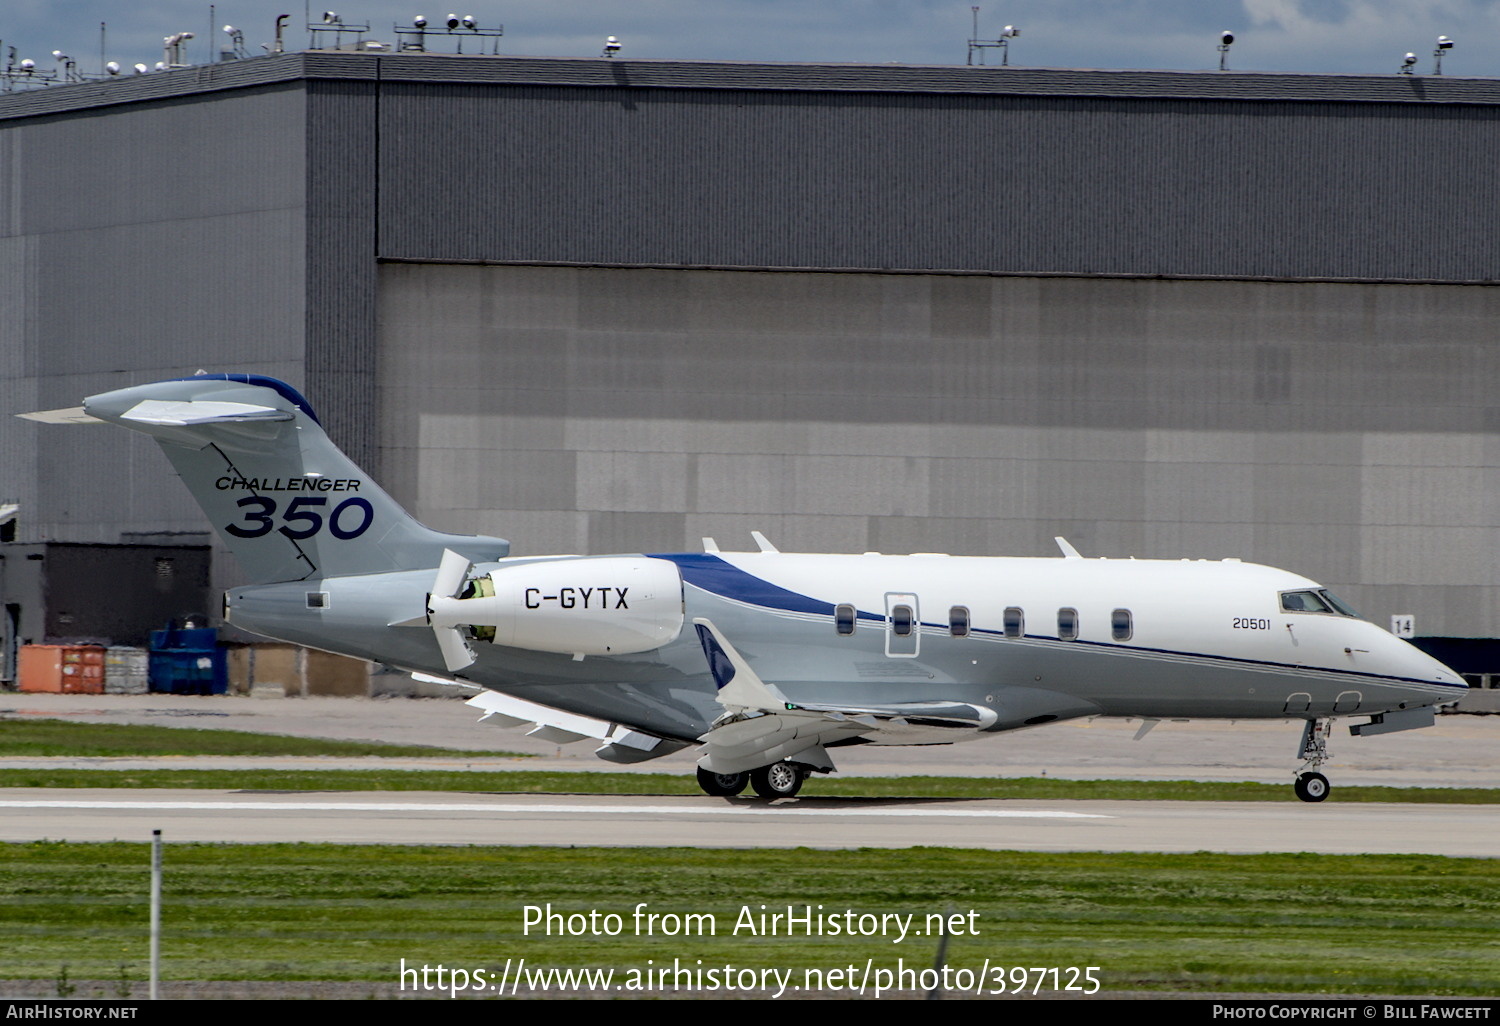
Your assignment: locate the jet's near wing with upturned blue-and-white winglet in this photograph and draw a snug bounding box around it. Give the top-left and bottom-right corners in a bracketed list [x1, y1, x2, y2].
[693, 618, 996, 774]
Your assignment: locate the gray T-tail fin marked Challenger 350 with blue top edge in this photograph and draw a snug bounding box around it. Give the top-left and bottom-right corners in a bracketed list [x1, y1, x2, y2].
[84, 374, 510, 584]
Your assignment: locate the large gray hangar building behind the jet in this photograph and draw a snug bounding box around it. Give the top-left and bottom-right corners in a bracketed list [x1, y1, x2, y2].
[0, 51, 1500, 672]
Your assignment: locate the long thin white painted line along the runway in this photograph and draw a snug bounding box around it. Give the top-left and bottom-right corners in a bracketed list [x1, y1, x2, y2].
[0, 801, 1115, 819]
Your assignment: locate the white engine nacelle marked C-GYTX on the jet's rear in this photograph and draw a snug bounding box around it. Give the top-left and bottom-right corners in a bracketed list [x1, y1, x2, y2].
[431, 557, 683, 656]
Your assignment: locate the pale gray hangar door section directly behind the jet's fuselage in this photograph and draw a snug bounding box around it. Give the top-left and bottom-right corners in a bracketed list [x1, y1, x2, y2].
[378, 264, 1500, 635]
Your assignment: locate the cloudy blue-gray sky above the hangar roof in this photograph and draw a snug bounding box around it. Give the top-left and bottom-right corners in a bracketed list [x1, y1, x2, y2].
[0, 0, 1500, 77]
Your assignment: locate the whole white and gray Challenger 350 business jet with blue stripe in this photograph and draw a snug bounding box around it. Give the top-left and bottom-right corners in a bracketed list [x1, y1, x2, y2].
[29, 374, 1466, 801]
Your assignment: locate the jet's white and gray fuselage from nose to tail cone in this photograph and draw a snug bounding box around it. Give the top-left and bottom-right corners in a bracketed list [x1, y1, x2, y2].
[231, 552, 1464, 743]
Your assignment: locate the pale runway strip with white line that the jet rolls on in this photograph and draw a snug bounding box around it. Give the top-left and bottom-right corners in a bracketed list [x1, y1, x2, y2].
[0, 788, 1500, 858]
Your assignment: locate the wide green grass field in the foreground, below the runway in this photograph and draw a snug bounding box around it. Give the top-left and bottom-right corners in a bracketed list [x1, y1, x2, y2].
[0, 842, 1500, 996]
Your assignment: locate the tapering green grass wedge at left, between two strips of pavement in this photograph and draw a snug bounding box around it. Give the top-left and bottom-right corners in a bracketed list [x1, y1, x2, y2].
[0, 717, 519, 759]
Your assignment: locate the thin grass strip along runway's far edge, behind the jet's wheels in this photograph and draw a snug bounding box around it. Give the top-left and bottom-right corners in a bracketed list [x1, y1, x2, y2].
[0, 768, 1500, 806]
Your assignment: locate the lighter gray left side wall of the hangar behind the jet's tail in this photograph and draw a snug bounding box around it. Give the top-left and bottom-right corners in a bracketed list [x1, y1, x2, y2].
[0, 87, 306, 600]
